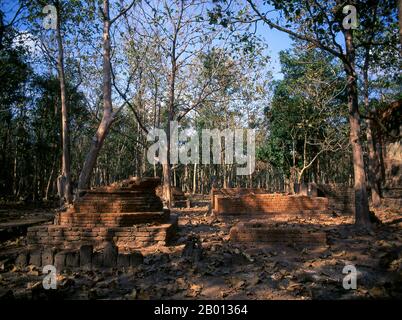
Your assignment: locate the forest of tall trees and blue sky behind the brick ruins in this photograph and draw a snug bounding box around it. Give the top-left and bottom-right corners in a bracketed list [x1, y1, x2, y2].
[0, 0, 402, 225]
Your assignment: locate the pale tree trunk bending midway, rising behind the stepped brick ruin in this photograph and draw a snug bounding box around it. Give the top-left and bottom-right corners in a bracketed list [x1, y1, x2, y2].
[78, 0, 114, 190]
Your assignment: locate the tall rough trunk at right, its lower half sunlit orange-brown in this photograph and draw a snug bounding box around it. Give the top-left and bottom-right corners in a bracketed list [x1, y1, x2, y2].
[344, 29, 370, 228]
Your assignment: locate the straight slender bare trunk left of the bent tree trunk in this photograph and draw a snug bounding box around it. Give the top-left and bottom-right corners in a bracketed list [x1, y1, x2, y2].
[56, 1, 72, 204]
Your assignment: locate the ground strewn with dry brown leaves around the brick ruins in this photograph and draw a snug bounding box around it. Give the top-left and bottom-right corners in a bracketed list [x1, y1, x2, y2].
[0, 208, 402, 300]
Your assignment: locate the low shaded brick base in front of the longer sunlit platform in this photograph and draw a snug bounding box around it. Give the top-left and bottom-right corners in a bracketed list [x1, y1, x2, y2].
[230, 223, 327, 246]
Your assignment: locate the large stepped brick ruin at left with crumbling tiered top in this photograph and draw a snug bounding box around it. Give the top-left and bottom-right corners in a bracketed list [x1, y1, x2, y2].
[23, 177, 177, 270]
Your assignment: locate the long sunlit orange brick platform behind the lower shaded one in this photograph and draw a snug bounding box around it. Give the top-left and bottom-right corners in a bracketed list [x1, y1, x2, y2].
[212, 194, 328, 217]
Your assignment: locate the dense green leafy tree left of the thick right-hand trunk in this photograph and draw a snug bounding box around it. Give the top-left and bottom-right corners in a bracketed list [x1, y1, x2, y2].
[258, 45, 347, 180]
